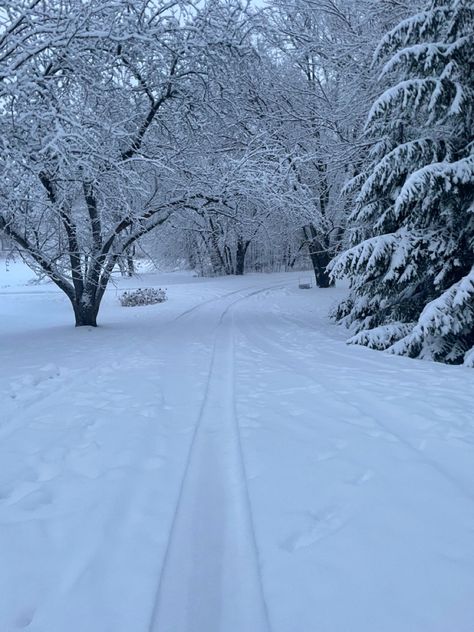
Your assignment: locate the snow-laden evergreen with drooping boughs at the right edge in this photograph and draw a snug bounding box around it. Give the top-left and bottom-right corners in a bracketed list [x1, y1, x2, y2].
[331, 0, 474, 366]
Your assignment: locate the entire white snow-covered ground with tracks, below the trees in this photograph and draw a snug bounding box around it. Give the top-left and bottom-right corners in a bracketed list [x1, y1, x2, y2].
[0, 264, 474, 632]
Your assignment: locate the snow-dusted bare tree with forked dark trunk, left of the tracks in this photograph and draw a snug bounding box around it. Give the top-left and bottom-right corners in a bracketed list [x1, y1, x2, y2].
[0, 0, 217, 326]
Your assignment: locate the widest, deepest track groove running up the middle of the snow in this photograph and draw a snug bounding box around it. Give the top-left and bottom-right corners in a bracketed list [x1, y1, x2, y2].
[149, 284, 281, 632]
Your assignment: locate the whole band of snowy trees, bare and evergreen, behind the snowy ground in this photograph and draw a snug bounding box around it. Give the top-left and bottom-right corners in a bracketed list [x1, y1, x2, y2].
[0, 0, 474, 364]
